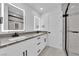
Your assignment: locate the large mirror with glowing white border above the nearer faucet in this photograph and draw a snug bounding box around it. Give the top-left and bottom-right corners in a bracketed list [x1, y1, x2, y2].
[1, 3, 25, 32]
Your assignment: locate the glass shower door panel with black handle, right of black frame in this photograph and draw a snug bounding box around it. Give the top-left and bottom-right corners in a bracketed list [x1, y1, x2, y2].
[67, 3, 79, 55]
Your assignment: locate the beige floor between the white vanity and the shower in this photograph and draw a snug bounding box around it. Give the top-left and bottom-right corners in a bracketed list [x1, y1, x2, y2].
[39, 47, 66, 56]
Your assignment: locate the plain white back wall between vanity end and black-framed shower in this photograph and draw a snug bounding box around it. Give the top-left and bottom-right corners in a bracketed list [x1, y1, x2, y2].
[48, 4, 63, 49]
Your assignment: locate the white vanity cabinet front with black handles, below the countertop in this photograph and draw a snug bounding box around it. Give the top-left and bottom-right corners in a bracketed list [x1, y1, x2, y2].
[0, 34, 47, 56]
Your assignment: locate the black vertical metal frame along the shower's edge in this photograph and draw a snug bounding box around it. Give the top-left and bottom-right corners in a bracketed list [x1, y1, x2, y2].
[63, 3, 70, 56]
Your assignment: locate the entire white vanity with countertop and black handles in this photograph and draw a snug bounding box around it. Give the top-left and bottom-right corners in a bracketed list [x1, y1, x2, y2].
[0, 33, 47, 56]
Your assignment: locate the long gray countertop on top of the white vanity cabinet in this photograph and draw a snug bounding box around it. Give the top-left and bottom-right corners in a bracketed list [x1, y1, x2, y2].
[0, 32, 47, 48]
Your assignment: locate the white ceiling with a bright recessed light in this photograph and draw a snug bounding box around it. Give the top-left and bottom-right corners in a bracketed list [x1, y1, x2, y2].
[26, 3, 60, 14]
